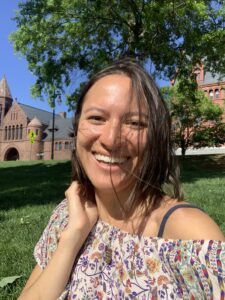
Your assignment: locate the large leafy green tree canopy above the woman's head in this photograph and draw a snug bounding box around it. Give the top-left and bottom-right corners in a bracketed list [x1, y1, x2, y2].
[11, 0, 225, 103]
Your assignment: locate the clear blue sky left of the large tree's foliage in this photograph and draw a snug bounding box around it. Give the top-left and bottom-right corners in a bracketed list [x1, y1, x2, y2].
[0, 0, 165, 116]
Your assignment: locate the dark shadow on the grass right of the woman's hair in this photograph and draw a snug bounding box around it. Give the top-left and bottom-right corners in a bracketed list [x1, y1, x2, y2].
[178, 155, 225, 183]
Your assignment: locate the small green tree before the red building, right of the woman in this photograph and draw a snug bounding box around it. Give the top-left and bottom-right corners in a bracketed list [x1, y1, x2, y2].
[162, 83, 225, 155]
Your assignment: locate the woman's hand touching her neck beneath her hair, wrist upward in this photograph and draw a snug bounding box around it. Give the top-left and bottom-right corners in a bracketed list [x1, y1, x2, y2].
[62, 181, 98, 239]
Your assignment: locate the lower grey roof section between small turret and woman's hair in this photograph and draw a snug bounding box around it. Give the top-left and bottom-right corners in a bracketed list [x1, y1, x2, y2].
[45, 118, 73, 141]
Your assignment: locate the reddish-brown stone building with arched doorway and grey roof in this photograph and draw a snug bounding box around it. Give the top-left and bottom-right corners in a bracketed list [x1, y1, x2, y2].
[0, 77, 73, 161]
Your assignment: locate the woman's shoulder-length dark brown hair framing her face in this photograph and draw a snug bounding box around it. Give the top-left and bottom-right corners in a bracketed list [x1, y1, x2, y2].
[72, 59, 181, 216]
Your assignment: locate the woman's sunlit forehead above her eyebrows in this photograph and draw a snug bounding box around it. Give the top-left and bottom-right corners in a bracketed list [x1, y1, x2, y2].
[83, 74, 146, 113]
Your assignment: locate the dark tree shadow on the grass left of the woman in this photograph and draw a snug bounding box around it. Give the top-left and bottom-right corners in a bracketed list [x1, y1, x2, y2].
[0, 161, 71, 210]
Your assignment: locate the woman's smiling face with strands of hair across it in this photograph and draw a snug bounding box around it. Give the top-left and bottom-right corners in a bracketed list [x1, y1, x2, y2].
[76, 74, 148, 195]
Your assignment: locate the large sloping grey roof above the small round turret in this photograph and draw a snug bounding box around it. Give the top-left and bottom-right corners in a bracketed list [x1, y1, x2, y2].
[18, 103, 61, 125]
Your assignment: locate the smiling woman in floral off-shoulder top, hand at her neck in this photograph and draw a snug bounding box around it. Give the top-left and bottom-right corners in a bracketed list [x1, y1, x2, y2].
[19, 60, 225, 300]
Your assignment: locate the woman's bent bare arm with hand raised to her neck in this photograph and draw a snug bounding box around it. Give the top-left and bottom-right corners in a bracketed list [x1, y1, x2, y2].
[19, 181, 98, 300]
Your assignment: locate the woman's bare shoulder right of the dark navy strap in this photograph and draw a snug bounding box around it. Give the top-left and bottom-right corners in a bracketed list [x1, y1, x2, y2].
[163, 202, 225, 241]
